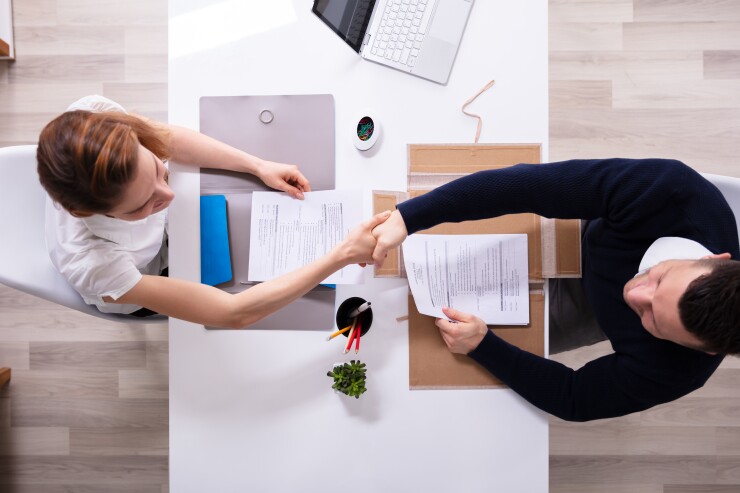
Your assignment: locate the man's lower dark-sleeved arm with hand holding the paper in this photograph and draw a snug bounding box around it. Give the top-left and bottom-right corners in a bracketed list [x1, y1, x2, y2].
[436, 308, 694, 421]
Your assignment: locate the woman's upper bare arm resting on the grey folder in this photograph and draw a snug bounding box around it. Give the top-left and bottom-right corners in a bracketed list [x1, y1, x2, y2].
[168, 125, 311, 199]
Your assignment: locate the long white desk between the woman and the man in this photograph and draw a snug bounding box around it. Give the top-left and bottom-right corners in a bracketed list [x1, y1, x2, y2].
[169, 0, 548, 493]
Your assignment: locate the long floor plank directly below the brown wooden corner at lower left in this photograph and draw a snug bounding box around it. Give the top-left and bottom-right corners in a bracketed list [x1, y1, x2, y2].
[10, 397, 169, 428]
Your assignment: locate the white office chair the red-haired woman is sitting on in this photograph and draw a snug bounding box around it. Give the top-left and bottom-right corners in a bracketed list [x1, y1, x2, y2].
[0, 145, 166, 323]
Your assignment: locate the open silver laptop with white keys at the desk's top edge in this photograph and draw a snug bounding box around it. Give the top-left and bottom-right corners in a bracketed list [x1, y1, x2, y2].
[312, 0, 473, 84]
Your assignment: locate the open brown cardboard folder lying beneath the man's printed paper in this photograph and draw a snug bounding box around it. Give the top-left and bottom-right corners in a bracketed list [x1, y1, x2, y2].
[373, 144, 581, 389]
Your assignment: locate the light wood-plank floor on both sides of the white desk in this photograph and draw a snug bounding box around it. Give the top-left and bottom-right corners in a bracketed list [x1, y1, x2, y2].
[0, 0, 740, 493]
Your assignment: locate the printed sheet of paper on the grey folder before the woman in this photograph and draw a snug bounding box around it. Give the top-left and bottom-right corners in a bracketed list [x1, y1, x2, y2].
[249, 190, 362, 284]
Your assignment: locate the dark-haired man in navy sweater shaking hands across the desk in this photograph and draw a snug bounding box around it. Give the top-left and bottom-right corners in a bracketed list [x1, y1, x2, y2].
[373, 159, 740, 421]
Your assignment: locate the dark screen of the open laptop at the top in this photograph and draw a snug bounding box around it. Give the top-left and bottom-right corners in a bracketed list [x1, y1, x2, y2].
[311, 0, 375, 53]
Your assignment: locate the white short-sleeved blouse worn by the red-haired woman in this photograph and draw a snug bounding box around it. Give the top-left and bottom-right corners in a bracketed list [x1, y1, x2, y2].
[46, 96, 168, 313]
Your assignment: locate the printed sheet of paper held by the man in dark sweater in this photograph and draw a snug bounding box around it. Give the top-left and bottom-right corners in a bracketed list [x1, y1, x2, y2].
[403, 234, 529, 325]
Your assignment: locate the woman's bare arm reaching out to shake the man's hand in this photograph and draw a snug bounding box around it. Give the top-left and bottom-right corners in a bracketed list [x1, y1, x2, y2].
[105, 211, 390, 329]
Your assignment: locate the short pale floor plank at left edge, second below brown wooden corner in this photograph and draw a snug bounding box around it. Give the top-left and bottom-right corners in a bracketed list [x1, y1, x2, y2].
[0, 426, 69, 456]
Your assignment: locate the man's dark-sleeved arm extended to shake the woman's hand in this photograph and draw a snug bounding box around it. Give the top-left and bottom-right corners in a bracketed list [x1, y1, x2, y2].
[373, 159, 695, 265]
